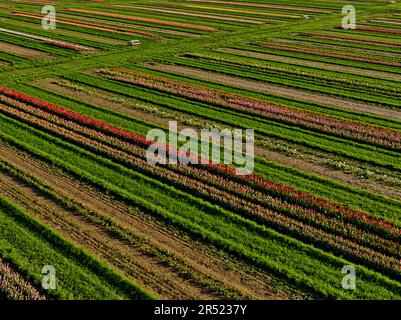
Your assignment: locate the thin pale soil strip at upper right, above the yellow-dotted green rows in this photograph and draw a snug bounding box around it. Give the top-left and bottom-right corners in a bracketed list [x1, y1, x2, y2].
[217, 48, 401, 81]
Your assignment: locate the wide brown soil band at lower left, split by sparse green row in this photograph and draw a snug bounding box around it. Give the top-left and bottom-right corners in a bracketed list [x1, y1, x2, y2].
[0, 144, 294, 299]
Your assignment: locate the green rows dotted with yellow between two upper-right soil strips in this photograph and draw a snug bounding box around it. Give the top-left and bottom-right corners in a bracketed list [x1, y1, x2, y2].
[168, 49, 400, 114]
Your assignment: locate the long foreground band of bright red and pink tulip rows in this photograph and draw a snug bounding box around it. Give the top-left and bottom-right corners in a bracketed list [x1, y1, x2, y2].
[1, 88, 400, 274]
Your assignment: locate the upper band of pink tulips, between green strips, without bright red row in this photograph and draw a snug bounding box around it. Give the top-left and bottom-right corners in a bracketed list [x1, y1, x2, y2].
[97, 68, 401, 150]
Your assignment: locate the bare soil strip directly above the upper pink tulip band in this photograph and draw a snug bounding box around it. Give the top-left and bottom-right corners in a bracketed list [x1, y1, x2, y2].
[151, 65, 401, 120]
